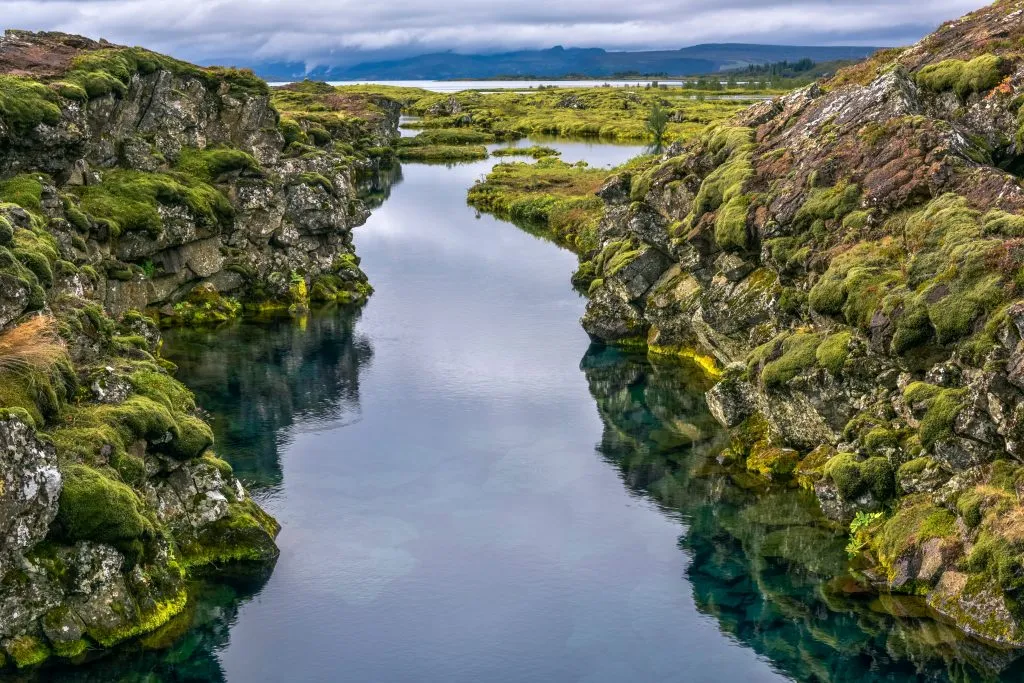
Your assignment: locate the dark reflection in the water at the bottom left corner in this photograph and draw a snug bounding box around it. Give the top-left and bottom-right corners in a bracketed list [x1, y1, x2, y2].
[25, 567, 272, 683]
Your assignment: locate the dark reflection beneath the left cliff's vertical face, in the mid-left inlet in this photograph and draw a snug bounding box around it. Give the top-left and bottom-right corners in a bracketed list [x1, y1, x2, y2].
[165, 309, 373, 489]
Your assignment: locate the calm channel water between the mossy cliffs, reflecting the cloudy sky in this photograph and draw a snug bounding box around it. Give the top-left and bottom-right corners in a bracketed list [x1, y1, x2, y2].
[41, 142, 1022, 683]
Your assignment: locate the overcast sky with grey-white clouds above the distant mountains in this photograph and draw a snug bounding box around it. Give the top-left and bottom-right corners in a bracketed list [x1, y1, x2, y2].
[0, 0, 988, 66]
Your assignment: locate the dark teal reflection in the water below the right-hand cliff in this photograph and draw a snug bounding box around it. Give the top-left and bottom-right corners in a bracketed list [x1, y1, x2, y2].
[582, 348, 1024, 682]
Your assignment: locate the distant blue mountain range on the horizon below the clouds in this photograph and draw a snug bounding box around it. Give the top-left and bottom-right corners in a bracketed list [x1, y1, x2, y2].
[253, 43, 878, 81]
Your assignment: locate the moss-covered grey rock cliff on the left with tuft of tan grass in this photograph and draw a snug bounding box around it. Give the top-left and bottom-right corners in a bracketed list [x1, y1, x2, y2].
[0, 32, 398, 669]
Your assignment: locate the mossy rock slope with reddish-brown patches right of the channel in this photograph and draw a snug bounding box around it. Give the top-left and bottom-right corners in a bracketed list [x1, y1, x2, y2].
[578, 0, 1024, 647]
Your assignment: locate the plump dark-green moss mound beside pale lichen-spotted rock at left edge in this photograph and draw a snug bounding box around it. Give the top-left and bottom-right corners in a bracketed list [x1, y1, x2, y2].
[55, 465, 154, 543]
